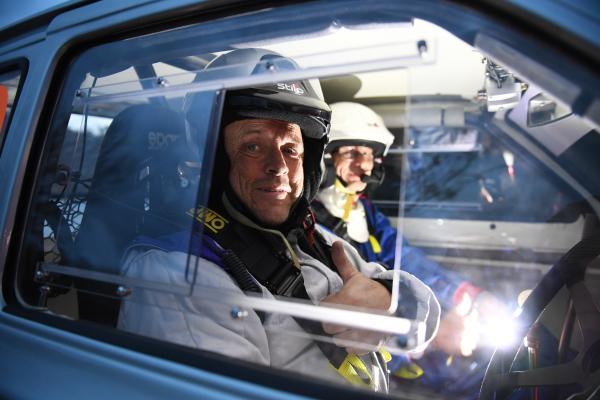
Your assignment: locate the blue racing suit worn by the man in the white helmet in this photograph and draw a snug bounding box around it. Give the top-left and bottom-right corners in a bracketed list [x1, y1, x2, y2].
[312, 183, 483, 398]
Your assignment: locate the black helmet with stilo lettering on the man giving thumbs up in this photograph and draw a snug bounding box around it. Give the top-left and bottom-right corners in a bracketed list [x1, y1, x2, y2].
[186, 48, 331, 225]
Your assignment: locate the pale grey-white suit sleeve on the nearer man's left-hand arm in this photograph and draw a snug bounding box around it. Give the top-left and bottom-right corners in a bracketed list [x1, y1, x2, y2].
[119, 250, 270, 365]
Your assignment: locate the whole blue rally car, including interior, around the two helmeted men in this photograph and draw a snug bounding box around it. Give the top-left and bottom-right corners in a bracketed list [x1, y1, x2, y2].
[0, 0, 600, 400]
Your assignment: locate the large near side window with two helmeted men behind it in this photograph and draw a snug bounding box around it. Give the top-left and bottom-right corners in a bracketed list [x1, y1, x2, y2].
[18, 4, 598, 398]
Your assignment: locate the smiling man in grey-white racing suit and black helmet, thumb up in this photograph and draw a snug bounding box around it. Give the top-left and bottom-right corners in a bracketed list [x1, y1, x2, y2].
[119, 49, 439, 392]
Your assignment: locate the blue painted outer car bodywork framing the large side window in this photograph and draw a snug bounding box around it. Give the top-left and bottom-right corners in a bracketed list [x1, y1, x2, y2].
[0, 0, 600, 399]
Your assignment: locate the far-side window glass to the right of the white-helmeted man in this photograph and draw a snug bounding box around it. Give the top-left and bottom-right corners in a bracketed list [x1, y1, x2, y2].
[375, 108, 581, 222]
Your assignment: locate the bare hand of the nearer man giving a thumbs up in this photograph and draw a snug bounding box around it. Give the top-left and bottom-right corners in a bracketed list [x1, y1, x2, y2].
[323, 241, 391, 355]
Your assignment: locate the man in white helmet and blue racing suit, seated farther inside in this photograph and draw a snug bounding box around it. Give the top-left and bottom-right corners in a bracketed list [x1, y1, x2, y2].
[312, 102, 506, 392]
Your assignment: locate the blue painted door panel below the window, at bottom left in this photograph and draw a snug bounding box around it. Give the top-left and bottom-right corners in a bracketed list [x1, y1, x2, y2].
[0, 313, 304, 400]
